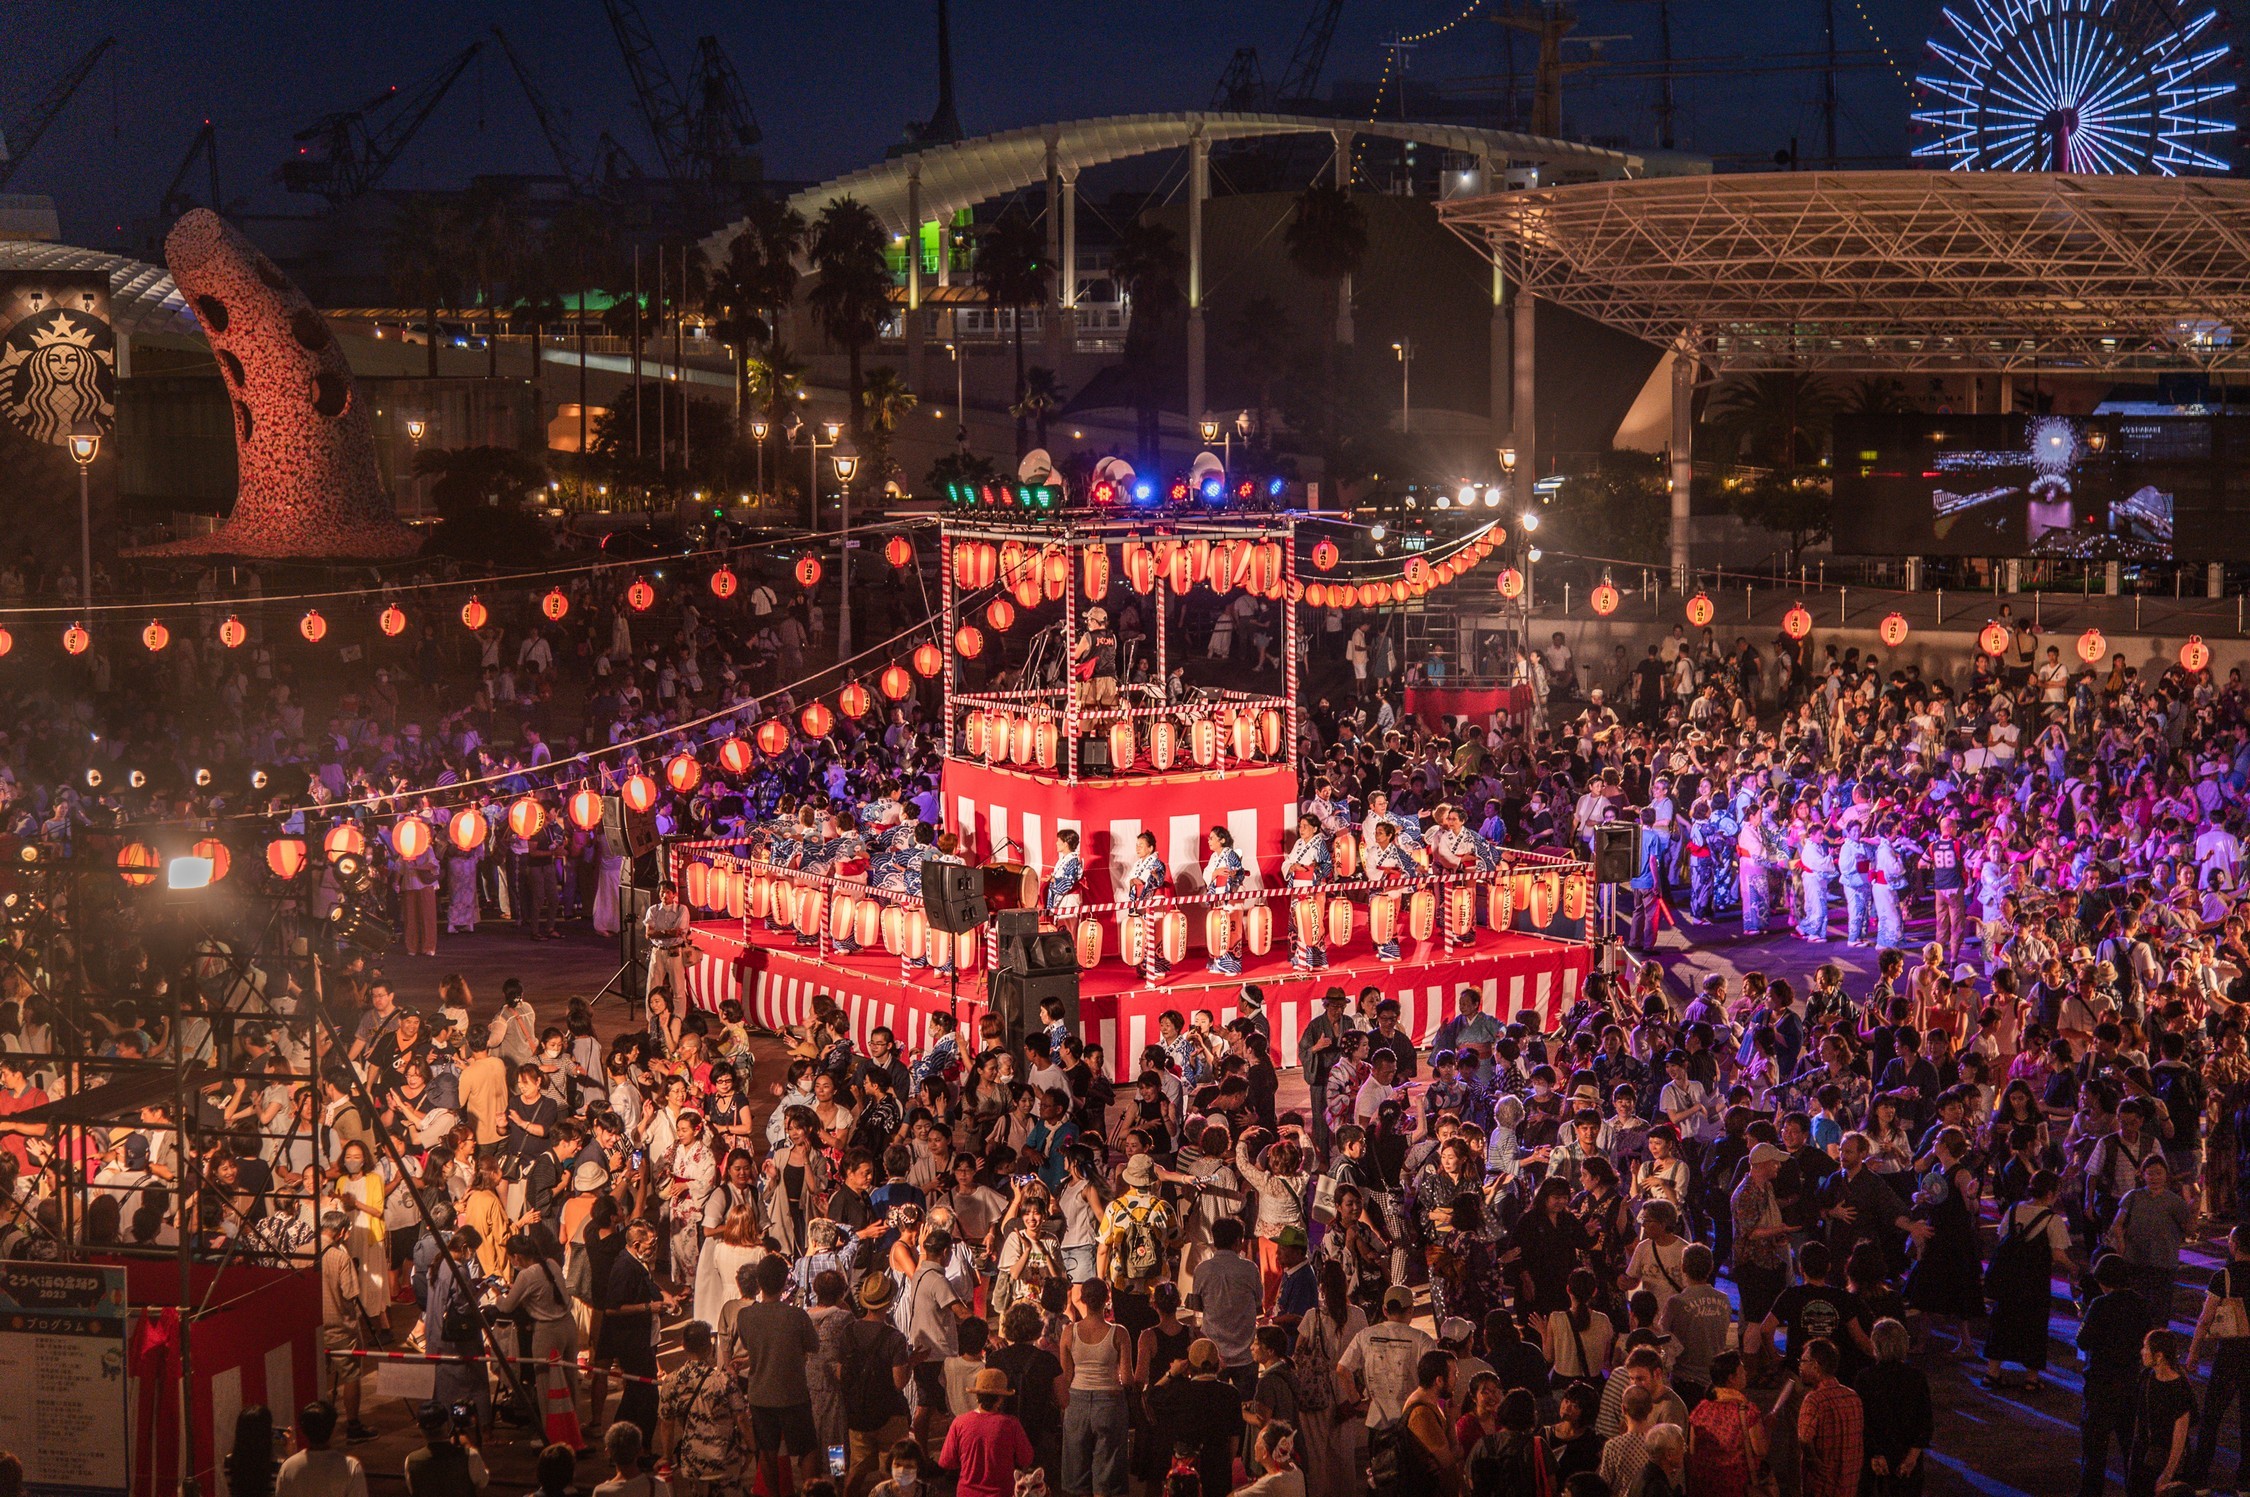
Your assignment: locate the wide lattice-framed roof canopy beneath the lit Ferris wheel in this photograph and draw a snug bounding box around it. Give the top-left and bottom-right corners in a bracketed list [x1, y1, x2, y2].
[1438, 171, 2250, 371]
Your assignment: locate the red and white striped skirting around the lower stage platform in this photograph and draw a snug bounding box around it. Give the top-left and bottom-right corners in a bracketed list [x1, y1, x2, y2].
[689, 921, 1593, 1081]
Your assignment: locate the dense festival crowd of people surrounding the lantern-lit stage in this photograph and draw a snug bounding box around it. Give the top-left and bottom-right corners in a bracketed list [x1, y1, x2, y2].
[21, 538, 2250, 1497]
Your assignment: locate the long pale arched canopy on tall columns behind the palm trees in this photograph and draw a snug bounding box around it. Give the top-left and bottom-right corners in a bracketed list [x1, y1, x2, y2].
[707, 113, 1688, 254]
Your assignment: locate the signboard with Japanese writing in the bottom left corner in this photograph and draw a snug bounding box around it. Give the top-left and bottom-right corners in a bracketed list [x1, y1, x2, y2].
[0, 1263, 131, 1497]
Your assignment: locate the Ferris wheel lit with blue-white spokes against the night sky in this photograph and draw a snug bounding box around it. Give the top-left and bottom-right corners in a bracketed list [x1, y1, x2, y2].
[1915, 0, 2234, 176]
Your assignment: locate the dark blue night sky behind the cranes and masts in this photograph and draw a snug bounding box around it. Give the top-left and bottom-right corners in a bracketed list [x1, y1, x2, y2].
[0, 0, 1937, 243]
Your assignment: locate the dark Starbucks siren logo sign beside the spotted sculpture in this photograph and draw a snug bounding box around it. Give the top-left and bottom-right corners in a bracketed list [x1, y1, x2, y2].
[0, 270, 117, 448]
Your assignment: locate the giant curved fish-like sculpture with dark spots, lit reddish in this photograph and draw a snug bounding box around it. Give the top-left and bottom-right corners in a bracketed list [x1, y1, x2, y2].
[135, 207, 421, 561]
